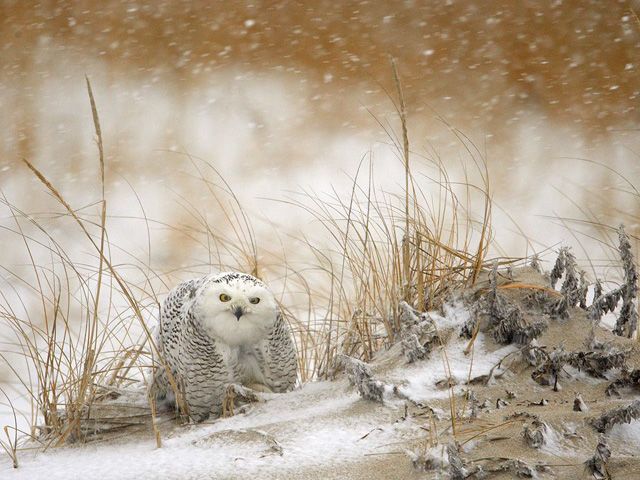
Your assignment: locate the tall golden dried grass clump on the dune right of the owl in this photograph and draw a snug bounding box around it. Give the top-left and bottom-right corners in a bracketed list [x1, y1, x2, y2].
[276, 72, 492, 378]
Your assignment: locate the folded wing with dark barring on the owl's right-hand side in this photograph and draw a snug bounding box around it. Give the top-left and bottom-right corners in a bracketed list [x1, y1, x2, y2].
[264, 309, 297, 392]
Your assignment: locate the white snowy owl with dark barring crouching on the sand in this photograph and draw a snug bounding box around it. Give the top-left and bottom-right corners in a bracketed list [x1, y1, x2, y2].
[151, 272, 297, 421]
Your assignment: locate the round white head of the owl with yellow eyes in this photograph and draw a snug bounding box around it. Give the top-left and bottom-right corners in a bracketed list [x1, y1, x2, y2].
[193, 272, 278, 346]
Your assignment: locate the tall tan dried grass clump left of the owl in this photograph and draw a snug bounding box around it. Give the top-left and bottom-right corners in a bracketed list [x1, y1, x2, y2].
[0, 79, 166, 463]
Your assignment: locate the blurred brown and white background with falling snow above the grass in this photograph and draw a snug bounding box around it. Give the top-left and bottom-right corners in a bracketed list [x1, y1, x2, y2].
[0, 0, 640, 258]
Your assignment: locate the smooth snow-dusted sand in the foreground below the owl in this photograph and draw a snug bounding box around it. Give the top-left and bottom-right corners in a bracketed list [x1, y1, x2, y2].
[0, 382, 388, 480]
